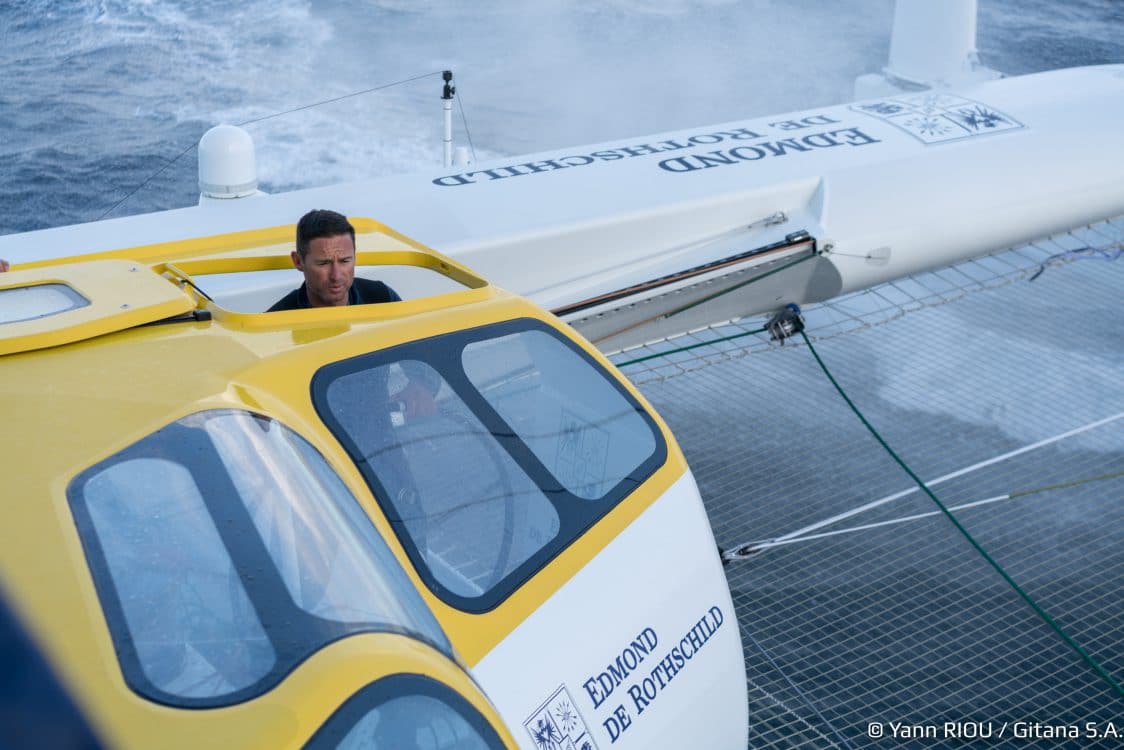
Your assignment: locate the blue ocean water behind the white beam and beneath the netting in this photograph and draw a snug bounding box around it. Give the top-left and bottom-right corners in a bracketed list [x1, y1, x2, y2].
[0, 0, 1124, 747]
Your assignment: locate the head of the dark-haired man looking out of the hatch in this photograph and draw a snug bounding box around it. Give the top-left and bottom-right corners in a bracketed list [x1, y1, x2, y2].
[291, 209, 355, 307]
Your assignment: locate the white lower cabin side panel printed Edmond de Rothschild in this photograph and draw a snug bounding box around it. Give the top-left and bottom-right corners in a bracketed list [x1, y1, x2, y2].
[473, 472, 747, 750]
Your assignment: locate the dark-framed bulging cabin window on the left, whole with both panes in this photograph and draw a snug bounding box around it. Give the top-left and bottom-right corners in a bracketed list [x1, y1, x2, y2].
[67, 410, 451, 706]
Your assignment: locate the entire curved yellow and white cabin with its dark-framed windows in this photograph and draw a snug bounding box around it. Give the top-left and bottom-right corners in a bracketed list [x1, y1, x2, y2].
[0, 219, 746, 750]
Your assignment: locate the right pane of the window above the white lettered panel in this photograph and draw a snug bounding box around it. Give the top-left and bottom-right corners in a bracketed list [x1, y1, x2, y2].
[464, 331, 655, 499]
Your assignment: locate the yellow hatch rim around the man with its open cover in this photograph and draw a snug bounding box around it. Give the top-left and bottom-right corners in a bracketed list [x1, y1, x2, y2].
[0, 218, 490, 355]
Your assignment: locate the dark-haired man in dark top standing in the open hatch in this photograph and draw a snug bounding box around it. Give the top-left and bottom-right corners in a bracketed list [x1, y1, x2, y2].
[269, 209, 401, 313]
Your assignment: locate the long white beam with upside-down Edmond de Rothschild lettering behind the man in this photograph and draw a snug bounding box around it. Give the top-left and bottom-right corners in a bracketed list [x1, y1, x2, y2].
[0, 65, 1124, 326]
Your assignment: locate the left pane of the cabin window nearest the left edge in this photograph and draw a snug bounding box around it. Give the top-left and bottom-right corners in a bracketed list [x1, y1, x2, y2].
[85, 459, 275, 697]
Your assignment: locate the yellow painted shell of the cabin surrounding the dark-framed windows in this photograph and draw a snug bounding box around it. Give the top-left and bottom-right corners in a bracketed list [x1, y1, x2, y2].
[0, 219, 686, 748]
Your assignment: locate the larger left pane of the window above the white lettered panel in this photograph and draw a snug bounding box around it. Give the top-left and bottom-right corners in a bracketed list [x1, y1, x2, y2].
[327, 361, 559, 597]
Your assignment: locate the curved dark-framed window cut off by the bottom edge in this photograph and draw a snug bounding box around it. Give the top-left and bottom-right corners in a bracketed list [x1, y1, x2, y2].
[305, 675, 504, 750]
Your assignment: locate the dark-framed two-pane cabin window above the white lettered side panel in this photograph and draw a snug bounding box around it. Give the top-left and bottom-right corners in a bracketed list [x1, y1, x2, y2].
[312, 320, 667, 612]
